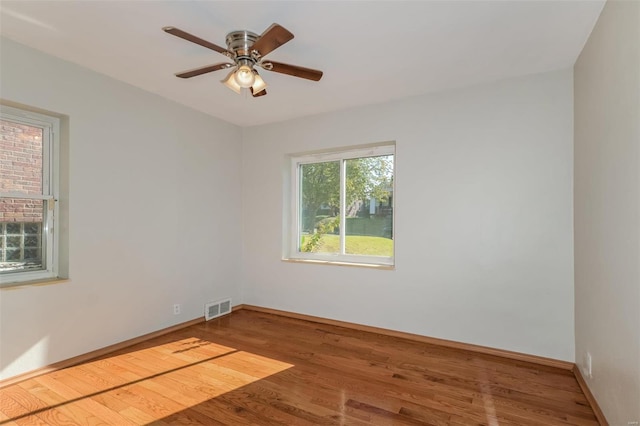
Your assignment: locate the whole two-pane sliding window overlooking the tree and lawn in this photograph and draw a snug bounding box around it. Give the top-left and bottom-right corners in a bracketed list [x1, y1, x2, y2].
[289, 145, 395, 265]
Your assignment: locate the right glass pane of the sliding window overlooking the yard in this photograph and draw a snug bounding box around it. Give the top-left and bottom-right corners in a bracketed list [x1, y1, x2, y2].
[345, 155, 393, 257]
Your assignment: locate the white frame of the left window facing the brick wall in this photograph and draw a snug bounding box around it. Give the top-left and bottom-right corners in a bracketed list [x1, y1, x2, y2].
[0, 105, 60, 287]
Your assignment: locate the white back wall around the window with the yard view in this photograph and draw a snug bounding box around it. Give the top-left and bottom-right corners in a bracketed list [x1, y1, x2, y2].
[243, 70, 574, 361]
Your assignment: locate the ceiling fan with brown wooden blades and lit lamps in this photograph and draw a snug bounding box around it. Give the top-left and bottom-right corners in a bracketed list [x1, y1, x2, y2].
[163, 24, 322, 97]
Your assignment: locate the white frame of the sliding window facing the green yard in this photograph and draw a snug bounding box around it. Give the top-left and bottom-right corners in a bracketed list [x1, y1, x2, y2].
[285, 142, 396, 267]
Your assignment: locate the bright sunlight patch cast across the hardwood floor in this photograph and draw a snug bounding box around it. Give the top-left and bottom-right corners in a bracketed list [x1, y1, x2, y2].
[2, 338, 293, 423]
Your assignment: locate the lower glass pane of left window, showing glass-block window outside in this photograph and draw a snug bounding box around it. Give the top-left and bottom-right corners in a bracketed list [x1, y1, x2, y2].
[0, 198, 46, 273]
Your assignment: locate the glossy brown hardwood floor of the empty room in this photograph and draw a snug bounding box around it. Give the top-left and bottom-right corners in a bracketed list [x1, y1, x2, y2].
[0, 310, 598, 426]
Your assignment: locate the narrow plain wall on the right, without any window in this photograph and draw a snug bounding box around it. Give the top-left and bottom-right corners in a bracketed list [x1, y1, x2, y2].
[574, 0, 640, 425]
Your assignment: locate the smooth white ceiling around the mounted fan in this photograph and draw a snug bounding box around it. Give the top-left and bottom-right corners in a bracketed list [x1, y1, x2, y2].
[0, 0, 604, 126]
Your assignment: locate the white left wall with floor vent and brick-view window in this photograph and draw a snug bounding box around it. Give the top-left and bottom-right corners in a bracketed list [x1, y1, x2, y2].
[0, 39, 242, 379]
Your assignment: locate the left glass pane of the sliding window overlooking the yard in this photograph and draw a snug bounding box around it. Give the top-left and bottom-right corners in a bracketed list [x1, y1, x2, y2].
[298, 161, 340, 253]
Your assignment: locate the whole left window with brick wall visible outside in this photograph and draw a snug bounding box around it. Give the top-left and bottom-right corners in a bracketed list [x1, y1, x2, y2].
[0, 105, 59, 284]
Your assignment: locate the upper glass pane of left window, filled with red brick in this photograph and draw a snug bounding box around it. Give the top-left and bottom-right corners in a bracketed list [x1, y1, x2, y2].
[0, 120, 43, 194]
